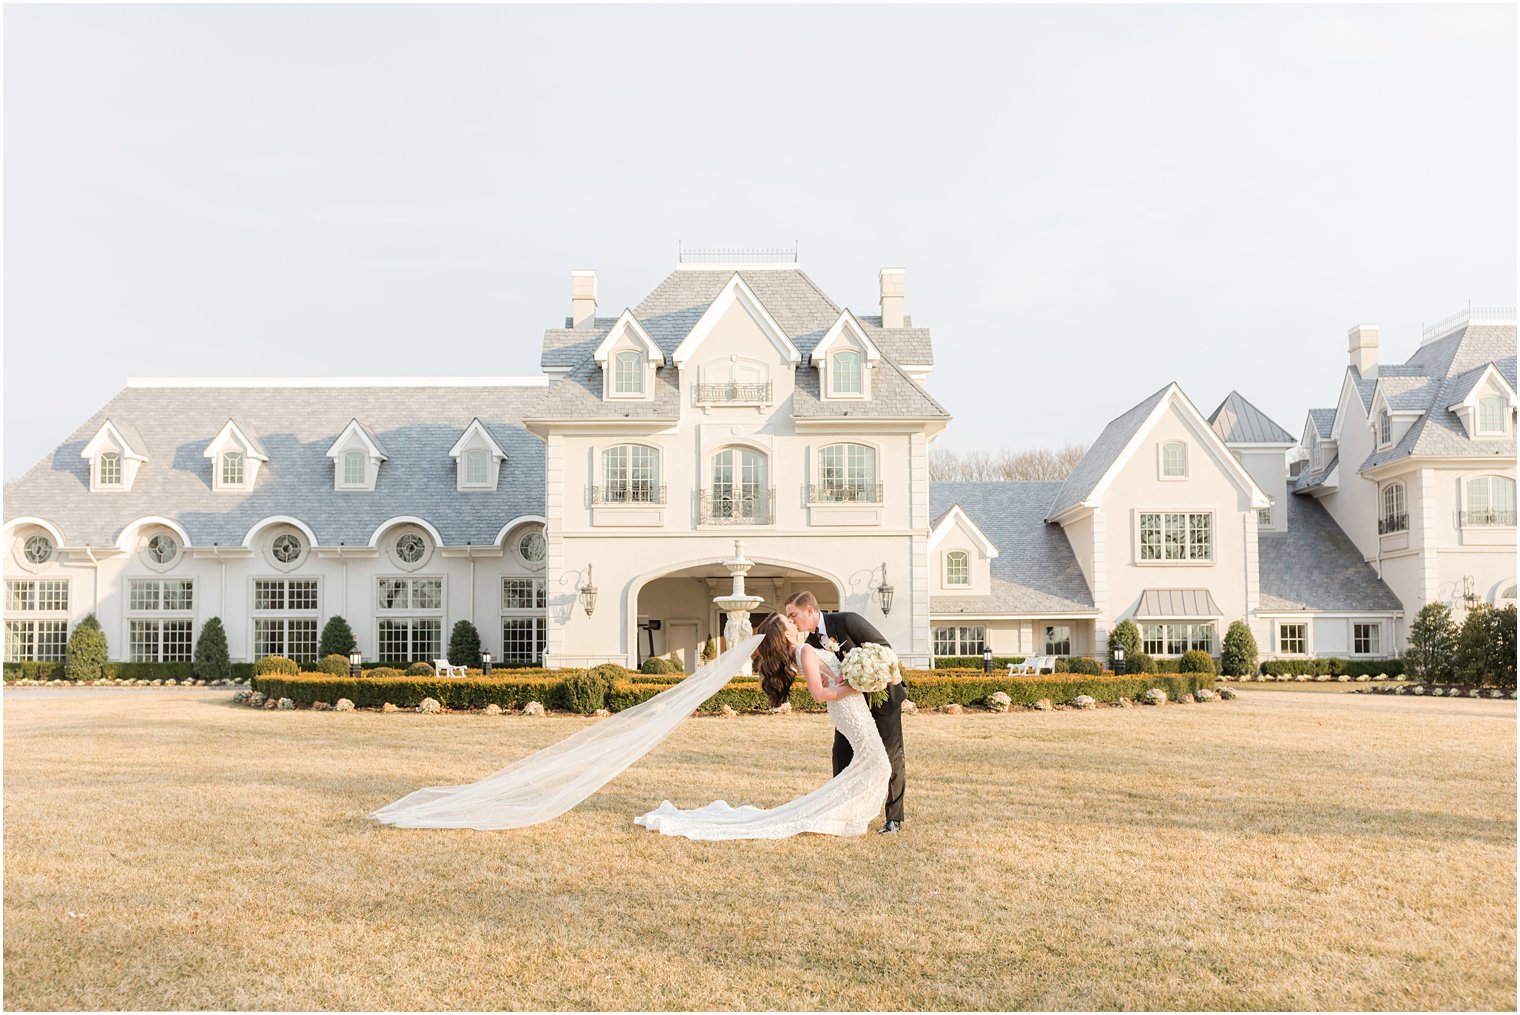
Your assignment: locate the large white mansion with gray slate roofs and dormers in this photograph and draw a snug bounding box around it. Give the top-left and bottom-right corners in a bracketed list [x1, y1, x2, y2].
[5, 255, 1515, 669]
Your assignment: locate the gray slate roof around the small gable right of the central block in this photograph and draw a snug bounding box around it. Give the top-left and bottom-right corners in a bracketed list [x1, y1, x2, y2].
[929, 480, 1094, 617]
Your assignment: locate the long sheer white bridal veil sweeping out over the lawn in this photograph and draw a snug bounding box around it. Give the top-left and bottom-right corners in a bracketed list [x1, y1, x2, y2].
[369, 635, 760, 831]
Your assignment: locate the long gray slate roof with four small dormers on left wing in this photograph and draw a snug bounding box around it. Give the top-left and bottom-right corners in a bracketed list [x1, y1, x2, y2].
[5, 386, 544, 547]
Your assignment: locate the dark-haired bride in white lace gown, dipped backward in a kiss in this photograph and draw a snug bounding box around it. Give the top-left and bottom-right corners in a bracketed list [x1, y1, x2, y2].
[634, 614, 892, 840]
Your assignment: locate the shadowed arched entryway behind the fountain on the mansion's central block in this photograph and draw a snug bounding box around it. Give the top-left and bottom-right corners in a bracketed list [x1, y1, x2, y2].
[629, 553, 839, 673]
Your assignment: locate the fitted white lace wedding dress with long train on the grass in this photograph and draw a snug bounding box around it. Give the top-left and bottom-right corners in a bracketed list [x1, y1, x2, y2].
[634, 646, 892, 840]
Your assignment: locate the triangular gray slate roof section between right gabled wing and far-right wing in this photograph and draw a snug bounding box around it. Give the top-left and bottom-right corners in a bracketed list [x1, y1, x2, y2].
[1257, 495, 1403, 612]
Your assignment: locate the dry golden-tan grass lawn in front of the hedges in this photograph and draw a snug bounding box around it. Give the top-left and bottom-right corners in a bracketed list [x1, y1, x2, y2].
[5, 688, 1515, 1009]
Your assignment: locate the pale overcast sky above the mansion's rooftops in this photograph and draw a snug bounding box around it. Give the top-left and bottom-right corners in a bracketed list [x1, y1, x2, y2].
[5, 6, 1517, 479]
